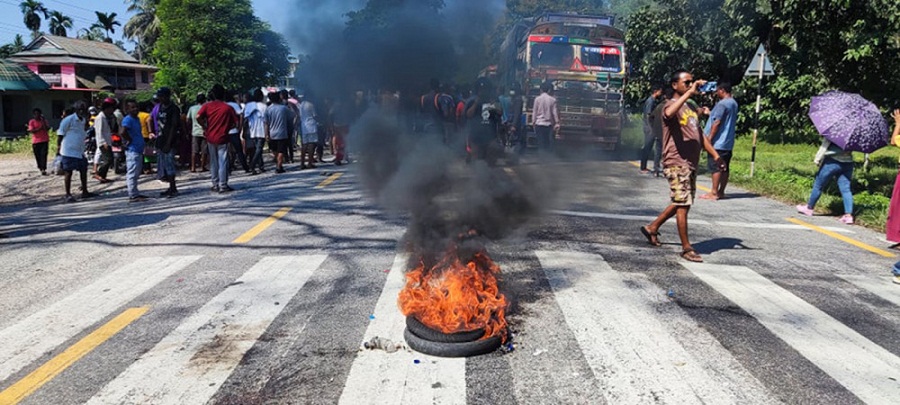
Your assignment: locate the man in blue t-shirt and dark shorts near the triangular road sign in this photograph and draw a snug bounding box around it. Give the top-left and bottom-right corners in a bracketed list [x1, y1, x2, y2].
[700, 82, 738, 200]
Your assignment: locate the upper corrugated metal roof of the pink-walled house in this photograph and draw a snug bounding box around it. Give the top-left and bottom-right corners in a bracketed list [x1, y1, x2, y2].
[10, 35, 151, 64]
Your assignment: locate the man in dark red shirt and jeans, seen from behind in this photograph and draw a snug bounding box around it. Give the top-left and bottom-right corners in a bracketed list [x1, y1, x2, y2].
[197, 84, 239, 193]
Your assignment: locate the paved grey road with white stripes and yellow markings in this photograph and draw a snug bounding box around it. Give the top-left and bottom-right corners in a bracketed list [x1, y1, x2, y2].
[0, 153, 900, 404]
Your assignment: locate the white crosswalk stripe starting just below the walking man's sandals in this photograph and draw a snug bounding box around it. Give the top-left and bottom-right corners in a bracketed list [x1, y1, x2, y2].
[682, 263, 900, 404]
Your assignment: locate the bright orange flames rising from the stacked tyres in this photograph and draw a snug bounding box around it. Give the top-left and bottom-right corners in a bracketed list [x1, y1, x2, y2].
[398, 246, 507, 342]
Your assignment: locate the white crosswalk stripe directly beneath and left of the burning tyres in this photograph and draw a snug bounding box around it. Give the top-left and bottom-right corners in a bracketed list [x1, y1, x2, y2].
[340, 255, 466, 405]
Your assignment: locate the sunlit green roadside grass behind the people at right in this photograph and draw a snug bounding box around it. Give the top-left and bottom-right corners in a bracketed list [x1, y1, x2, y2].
[622, 118, 900, 232]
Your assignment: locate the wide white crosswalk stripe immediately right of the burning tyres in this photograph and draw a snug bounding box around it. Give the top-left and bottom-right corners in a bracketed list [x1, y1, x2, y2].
[536, 251, 776, 404]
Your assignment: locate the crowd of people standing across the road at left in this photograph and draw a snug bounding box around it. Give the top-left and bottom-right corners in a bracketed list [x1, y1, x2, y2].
[34, 85, 366, 202]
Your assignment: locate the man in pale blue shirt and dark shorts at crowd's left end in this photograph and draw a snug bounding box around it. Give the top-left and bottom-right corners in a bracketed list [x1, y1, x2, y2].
[57, 101, 96, 202]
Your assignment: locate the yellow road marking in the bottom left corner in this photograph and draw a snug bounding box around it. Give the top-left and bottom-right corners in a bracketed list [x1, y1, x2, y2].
[0, 307, 150, 405]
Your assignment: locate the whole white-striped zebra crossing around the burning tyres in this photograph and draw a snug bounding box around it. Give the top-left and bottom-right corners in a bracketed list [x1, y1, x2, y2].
[0, 250, 900, 405]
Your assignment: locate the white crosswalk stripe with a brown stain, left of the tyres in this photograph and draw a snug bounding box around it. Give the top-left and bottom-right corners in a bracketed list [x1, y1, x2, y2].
[88, 255, 326, 405]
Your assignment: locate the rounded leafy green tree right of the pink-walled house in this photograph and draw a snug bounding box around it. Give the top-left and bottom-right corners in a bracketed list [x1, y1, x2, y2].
[153, 0, 288, 94]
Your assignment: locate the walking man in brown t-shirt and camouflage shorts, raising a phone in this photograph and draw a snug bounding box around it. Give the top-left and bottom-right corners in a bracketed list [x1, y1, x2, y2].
[641, 70, 724, 262]
